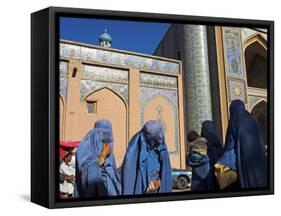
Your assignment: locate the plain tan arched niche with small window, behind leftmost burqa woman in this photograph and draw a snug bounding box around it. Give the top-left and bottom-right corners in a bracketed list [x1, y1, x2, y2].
[82, 88, 128, 166]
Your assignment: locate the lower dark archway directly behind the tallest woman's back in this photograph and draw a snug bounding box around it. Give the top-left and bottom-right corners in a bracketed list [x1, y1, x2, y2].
[251, 100, 267, 147]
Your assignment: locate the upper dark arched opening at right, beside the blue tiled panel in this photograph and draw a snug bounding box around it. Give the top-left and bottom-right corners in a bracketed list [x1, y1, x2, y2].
[245, 35, 267, 89]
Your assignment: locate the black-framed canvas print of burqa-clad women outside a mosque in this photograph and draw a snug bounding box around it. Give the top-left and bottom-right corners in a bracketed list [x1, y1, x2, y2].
[31, 7, 274, 208]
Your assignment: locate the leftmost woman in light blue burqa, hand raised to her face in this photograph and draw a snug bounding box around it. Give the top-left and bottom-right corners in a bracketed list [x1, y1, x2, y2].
[76, 119, 121, 198]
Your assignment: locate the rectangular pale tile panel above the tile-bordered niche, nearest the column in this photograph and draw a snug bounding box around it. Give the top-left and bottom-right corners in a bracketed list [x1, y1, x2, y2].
[140, 73, 177, 89]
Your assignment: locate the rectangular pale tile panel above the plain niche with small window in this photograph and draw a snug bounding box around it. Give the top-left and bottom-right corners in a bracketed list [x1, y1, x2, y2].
[81, 65, 128, 83]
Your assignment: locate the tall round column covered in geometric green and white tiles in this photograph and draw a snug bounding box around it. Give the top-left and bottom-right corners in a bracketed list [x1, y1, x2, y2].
[180, 24, 212, 133]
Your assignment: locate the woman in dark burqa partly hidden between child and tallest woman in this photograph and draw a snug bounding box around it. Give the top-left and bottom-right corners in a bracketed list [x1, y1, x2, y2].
[201, 120, 224, 191]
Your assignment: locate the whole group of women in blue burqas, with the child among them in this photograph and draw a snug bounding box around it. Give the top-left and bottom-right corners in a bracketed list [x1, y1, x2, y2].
[59, 100, 267, 198]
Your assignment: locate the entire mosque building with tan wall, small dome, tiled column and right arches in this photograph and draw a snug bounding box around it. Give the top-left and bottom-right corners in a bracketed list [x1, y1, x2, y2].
[59, 24, 267, 169]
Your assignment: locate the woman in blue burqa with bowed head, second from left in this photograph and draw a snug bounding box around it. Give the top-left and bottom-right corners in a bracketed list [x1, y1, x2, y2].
[121, 120, 172, 195]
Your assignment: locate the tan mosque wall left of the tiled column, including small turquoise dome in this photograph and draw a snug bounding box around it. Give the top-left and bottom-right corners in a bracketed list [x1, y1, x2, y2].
[59, 32, 186, 168]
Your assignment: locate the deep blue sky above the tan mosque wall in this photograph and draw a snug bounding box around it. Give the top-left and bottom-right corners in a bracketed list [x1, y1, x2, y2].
[60, 17, 170, 54]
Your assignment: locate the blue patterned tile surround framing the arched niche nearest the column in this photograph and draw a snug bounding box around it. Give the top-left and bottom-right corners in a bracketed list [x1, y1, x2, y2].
[140, 87, 179, 154]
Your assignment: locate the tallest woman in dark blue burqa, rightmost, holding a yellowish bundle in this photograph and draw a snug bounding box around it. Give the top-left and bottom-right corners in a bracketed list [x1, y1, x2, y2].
[216, 100, 267, 189]
